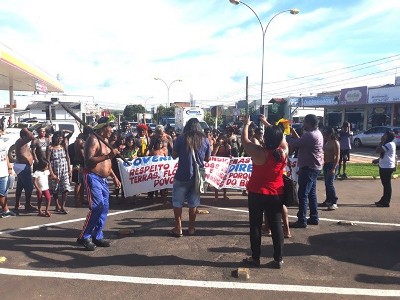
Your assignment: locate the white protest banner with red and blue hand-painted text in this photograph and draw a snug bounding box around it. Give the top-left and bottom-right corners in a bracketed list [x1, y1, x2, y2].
[118, 156, 298, 197]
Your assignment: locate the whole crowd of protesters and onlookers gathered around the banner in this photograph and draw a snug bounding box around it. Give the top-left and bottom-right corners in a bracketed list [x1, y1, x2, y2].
[0, 115, 396, 268]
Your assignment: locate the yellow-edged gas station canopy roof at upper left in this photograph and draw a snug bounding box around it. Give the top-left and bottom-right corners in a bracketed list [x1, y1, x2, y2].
[0, 44, 64, 93]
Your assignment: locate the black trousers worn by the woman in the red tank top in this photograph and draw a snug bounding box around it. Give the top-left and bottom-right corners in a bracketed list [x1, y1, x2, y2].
[248, 193, 283, 261]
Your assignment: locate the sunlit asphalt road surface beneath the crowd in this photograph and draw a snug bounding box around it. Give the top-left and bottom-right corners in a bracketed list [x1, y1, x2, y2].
[0, 180, 400, 300]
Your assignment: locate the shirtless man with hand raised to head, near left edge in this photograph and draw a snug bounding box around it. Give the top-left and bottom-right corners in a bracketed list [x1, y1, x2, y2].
[14, 128, 36, 212]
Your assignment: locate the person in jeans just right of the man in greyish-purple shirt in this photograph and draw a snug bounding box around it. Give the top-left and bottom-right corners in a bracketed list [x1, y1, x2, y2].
[321, 127, 340, 210]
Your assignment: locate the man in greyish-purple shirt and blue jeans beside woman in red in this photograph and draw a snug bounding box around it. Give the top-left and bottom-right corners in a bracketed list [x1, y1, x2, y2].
[289, 114, 324, 228]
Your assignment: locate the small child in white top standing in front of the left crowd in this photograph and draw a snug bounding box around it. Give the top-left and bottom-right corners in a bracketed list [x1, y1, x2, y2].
[32, 160, 51, 217]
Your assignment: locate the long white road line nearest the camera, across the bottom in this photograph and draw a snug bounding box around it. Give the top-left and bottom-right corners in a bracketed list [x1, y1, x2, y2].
[0, 268, 400, 297]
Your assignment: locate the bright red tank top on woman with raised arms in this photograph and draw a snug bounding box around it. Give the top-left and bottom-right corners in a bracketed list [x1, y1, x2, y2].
[247, 150, 286, 195]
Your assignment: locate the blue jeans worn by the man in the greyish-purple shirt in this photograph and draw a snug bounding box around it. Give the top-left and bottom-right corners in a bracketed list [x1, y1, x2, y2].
[297, 167, 321, 225]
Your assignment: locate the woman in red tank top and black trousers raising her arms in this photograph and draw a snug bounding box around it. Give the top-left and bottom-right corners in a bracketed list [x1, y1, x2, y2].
[242, 119, 287, 268]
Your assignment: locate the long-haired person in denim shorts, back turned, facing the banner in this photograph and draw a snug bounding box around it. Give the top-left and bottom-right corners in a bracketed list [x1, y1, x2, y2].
[169, 118, 211, 237]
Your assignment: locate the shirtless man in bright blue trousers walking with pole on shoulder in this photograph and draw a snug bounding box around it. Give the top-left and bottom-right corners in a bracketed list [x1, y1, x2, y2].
[77, 117, 121, 251]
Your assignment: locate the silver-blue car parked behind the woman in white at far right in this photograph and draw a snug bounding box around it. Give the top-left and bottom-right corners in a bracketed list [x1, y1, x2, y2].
[353, 126, 400, 147]
